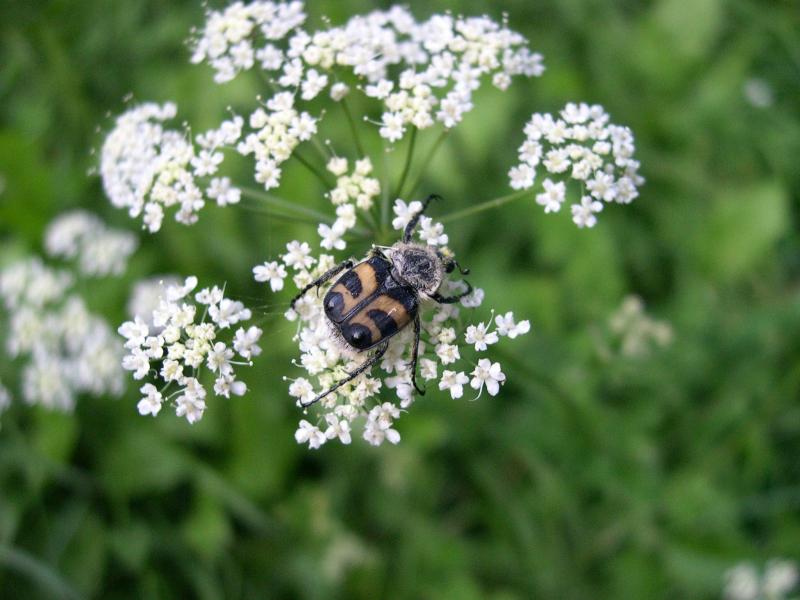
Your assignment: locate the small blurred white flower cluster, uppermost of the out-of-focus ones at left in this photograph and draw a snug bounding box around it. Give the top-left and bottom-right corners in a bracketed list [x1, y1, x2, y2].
[44, 210, 138, 277]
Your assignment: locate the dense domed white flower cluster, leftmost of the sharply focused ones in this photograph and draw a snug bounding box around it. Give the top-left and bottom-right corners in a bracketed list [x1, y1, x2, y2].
[100, 103, 244, 232]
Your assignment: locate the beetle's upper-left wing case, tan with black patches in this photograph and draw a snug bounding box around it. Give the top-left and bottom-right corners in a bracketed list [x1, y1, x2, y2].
[322, 256, 392, 323]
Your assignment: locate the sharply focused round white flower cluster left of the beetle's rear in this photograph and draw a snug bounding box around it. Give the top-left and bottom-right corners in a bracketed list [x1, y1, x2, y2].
[118, 277, 262, 423]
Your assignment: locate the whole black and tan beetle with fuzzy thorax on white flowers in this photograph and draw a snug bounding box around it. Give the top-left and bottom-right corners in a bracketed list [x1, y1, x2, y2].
[291, 194, 472, 407]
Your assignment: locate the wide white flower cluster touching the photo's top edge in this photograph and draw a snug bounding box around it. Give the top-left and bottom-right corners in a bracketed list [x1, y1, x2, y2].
[192, 1, 544, 142]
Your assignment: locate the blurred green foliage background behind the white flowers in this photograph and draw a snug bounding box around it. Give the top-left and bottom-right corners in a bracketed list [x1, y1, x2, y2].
[0, 0, 800, 600]
